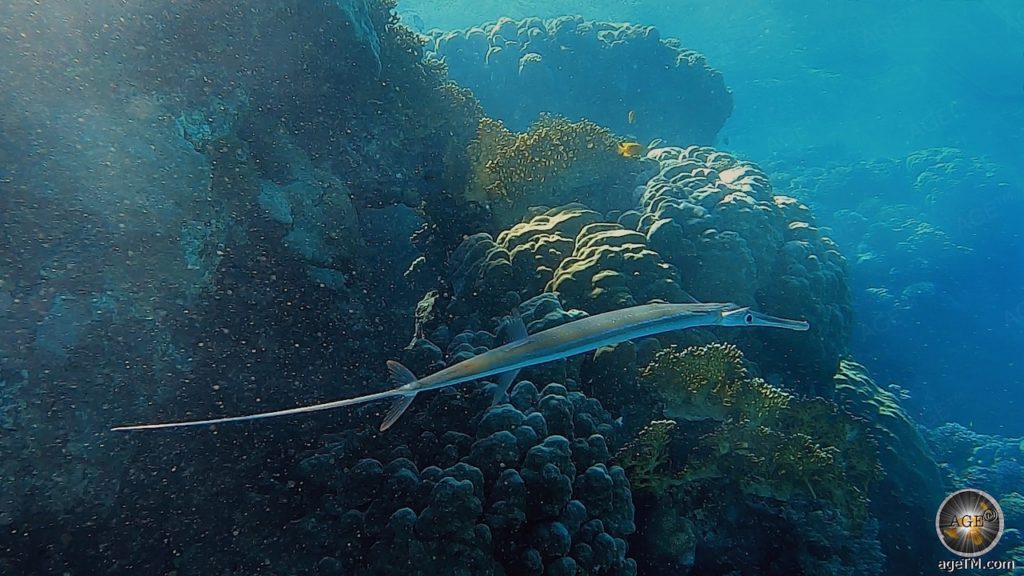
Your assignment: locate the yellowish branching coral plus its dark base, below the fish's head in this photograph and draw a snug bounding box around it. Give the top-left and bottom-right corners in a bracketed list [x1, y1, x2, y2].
[613, 344, 885, 574]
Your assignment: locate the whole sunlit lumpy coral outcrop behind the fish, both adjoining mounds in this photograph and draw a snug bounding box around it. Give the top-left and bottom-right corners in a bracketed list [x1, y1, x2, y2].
[436, 147, 852, 389]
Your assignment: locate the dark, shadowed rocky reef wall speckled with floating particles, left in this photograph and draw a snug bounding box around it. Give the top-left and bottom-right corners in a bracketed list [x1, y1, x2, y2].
[0, 0, 479, 574]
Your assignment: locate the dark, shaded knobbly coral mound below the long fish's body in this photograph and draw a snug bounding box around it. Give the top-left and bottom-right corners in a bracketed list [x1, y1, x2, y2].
[276, 377, 636, 575]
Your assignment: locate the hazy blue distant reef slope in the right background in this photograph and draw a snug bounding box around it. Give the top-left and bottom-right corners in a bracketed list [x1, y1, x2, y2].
[772, 149, 1024, 426]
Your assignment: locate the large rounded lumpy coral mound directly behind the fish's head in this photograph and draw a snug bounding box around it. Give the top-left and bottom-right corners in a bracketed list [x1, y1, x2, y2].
[637, 147, 852, 385]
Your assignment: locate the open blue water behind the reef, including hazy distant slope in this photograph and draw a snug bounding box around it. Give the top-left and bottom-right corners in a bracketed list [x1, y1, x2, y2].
[399, 0, 1024, 435]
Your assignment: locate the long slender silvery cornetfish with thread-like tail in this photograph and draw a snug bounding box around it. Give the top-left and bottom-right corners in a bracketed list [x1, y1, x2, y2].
[113, 303, 810, 431]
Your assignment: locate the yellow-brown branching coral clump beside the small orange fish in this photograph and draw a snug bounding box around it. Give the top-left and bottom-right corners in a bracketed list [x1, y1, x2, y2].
[465, 115, 635, 229]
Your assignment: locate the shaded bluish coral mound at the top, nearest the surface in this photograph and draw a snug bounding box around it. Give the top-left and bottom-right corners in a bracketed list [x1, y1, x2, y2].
[428, 16, 732, 143]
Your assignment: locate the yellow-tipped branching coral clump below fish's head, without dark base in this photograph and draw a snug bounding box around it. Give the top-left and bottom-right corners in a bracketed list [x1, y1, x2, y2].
[630, 344, 880, 521]
